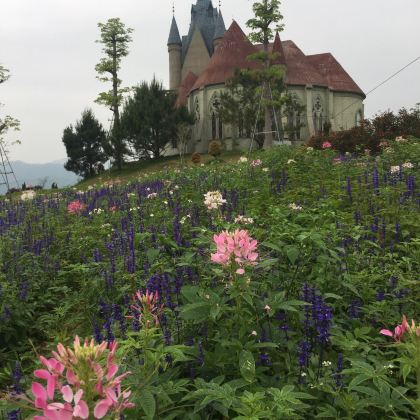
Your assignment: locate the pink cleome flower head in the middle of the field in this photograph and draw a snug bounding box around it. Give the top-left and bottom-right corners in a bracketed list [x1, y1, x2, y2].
[211, 229, 258, 274]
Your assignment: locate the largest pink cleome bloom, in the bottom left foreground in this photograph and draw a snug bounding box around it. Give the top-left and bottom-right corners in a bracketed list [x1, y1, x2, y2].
[27, 336, 134, 420]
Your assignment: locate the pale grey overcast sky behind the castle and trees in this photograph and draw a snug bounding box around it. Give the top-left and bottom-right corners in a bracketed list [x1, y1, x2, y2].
[0, 0, 420, 163]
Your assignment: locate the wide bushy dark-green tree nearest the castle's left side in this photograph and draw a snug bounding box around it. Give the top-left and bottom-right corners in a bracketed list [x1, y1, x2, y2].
[121, 79, 194, 159]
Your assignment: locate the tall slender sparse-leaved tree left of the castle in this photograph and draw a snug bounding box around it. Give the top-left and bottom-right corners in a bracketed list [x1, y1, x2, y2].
[95, 18, 133, 170]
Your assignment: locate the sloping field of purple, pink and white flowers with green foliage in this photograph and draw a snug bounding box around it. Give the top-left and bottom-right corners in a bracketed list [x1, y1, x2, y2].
[0, 137, 420, 420]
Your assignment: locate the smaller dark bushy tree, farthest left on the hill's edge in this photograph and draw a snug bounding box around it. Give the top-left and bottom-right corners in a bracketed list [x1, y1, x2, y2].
[62, 109, 107, 178]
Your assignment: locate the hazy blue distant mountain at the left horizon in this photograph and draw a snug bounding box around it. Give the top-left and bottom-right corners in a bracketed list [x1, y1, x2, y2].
[0, 159, 79, 194]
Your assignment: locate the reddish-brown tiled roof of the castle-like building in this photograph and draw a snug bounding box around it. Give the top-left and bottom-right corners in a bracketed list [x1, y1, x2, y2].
[184, 21, 365, 98]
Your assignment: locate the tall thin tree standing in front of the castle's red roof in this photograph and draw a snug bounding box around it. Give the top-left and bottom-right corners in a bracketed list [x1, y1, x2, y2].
[246, 0, 284, 149]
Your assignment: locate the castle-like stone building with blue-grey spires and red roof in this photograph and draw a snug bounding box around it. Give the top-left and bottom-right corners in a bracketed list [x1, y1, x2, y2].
[167, 0, 365, 153]
